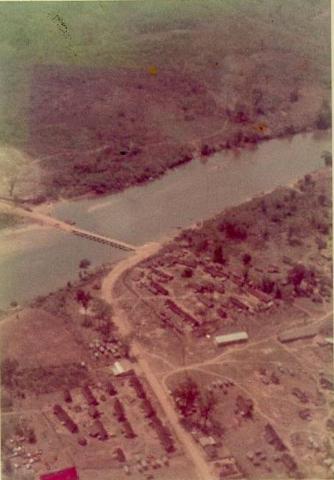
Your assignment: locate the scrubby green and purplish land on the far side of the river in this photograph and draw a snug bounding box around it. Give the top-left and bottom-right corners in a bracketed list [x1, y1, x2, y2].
[0, 0, 330, 197]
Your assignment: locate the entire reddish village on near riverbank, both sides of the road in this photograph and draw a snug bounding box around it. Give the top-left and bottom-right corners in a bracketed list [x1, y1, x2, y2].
[2, 167, 334, 480]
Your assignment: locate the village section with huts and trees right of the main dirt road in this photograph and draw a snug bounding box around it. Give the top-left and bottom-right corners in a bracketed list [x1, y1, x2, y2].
[113, 169, 334, 478]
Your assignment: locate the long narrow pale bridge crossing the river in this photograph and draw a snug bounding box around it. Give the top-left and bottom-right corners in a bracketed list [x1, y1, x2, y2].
[0, 199, 137, 252]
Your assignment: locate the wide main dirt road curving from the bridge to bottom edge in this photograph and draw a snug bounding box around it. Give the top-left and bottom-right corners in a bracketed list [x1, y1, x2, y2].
[101, 243, 214, 480]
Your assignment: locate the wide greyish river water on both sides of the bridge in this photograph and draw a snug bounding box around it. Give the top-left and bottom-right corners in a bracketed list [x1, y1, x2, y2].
[0, 133, 331, 309]
